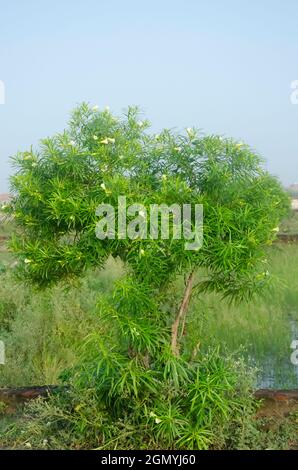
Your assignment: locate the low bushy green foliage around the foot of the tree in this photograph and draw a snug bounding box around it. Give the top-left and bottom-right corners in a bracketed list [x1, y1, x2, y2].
[0, 352, 256, 449]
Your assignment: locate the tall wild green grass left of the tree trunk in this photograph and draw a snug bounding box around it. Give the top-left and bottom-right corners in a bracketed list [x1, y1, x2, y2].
[0, 262, 121, 387]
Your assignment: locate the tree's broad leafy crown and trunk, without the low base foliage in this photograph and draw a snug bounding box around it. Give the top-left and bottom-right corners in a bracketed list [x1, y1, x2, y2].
[10, 104, 289, 447]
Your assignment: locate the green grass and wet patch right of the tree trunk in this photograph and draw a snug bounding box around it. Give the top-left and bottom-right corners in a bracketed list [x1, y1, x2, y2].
[188, 244, 298, 388]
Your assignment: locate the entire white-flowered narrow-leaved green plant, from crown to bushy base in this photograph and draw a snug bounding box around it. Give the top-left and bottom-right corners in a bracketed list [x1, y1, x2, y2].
[6, 103, 289, 449]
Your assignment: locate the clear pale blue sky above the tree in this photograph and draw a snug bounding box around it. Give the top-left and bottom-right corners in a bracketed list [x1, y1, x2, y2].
[0, 0, 298, 193]
